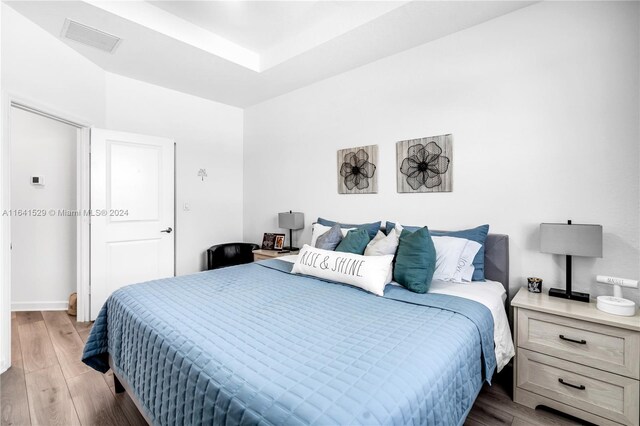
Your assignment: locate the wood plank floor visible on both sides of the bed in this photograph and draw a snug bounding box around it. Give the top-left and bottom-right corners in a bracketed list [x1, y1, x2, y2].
[0, 312, 592, 426]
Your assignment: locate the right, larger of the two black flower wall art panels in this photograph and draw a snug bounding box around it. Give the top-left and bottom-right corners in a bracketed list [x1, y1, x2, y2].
[396, 134, 453, 192]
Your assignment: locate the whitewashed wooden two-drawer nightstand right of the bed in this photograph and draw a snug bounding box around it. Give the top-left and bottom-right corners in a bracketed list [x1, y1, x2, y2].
[511, 288, 640, 425]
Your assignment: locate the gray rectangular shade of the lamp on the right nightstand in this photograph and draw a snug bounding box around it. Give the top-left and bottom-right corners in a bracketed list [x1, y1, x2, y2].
[540, 223, 602, 257]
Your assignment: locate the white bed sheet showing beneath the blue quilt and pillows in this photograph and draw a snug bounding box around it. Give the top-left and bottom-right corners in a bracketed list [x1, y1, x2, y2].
[278, 255, 516, 372]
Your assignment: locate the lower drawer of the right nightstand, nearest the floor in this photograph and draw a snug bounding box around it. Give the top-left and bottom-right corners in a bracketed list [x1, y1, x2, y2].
[516, 348, 640, 425]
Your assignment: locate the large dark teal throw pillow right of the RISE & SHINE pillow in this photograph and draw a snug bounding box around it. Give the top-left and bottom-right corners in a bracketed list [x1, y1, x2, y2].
[393, 226, 436, 293]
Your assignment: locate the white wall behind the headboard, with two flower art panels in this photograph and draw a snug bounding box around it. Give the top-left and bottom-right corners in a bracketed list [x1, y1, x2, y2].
[244, 2, 640, 301]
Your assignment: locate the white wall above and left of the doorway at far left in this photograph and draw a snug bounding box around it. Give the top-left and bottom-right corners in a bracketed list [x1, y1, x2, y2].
[0, 3, 105, 362]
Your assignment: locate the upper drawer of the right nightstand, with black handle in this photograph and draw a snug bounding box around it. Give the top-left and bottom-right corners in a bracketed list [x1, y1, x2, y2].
[517, 309, 640, 379]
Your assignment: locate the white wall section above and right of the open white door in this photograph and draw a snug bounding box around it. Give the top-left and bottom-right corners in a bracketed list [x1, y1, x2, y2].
[106, 73, 243, 275]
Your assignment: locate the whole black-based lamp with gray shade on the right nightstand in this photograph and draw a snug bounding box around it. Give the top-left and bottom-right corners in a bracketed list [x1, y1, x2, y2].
[540, 220, 602, 302]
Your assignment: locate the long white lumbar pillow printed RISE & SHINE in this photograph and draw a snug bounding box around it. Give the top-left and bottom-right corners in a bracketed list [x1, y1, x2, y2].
[291, 244, 393, 296]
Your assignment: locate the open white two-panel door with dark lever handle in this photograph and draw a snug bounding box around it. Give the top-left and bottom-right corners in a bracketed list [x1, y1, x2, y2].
[91, 129, 175, 320]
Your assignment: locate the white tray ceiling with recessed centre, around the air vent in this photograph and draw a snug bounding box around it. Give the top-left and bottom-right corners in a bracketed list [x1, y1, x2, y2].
[5, 0, 534, 107]
